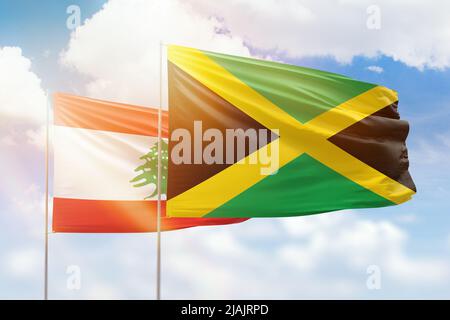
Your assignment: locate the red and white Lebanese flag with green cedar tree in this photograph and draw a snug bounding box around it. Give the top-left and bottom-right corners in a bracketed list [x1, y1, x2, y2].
[53, 93, 246, 233]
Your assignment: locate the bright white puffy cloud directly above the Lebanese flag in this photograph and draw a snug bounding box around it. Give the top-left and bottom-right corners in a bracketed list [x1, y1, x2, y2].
[61, 0, 249, 106]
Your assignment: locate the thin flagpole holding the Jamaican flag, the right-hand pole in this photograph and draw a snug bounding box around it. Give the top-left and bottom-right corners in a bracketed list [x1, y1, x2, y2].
[156, 41, 163, 300]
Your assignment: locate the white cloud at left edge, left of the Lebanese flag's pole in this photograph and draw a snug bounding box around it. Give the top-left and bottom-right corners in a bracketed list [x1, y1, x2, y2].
[0, 47, 47, 242]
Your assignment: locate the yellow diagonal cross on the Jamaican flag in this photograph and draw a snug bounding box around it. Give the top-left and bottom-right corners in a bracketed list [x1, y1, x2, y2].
[167, 46, 414, 217]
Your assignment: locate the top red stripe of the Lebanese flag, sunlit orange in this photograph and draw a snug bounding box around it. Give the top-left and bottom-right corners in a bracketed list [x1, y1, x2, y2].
[53, 93, 168, 138]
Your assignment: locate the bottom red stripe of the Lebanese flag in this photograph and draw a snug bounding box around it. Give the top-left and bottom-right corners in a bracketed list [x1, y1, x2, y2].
[53, 198, 247, 233]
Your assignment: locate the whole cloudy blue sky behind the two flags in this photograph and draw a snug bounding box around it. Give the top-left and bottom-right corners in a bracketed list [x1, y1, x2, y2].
[0, 0, 450, 299]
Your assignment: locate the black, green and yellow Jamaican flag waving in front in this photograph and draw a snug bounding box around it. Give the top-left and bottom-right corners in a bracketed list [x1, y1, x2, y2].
[167, 46, 416, 218]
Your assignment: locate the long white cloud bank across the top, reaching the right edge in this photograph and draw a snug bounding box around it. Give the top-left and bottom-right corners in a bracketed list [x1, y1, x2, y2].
[60, 0, 450, 106]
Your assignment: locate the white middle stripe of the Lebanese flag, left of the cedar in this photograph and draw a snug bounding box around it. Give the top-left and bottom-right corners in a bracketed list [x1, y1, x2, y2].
[54, 126, 163, 200]
